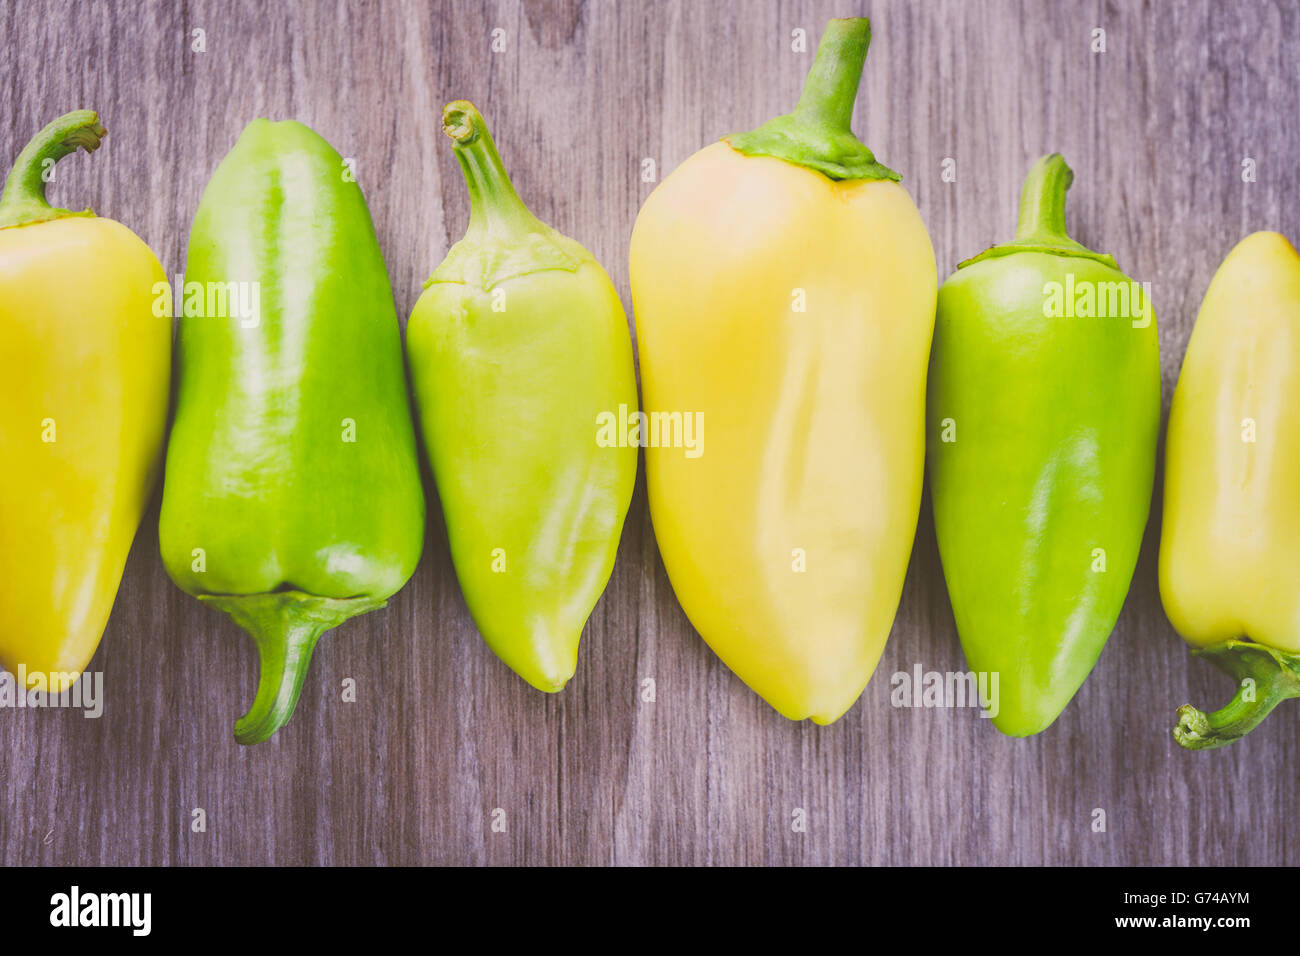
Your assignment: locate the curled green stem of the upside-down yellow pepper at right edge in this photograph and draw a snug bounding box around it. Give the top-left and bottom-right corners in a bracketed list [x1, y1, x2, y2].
[1174, 641, 1300, 750]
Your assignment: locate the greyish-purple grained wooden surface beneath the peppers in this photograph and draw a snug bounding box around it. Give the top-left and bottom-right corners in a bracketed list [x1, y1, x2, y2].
[0, 0, 1300, 865]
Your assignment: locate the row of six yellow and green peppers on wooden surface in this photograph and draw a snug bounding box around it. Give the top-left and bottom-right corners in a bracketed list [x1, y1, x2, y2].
[0, 18, 1300, 748]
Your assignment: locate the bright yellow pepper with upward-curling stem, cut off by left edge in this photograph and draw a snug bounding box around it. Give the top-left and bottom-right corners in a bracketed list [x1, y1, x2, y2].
[0, 109, 172, 693]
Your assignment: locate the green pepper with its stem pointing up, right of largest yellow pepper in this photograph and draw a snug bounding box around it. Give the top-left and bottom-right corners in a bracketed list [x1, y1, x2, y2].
[927, 155, 1160, 736]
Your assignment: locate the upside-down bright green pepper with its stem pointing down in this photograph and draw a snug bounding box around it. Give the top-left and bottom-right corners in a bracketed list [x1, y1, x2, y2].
[159, 120, 424, 744]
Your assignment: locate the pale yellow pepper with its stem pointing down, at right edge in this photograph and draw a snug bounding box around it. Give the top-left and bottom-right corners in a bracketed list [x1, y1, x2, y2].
[1160, 233, 1300, 750]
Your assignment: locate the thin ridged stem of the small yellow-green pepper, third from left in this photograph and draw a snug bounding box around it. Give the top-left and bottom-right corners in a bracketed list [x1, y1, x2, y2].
[442, 100, 545, 233]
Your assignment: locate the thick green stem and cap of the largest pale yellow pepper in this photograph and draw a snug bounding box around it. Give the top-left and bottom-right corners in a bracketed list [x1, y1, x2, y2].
[724, 17, 901, 181]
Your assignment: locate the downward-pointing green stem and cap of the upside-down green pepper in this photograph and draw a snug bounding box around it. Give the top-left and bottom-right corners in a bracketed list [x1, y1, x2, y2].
[199, 591, 386, 744]
